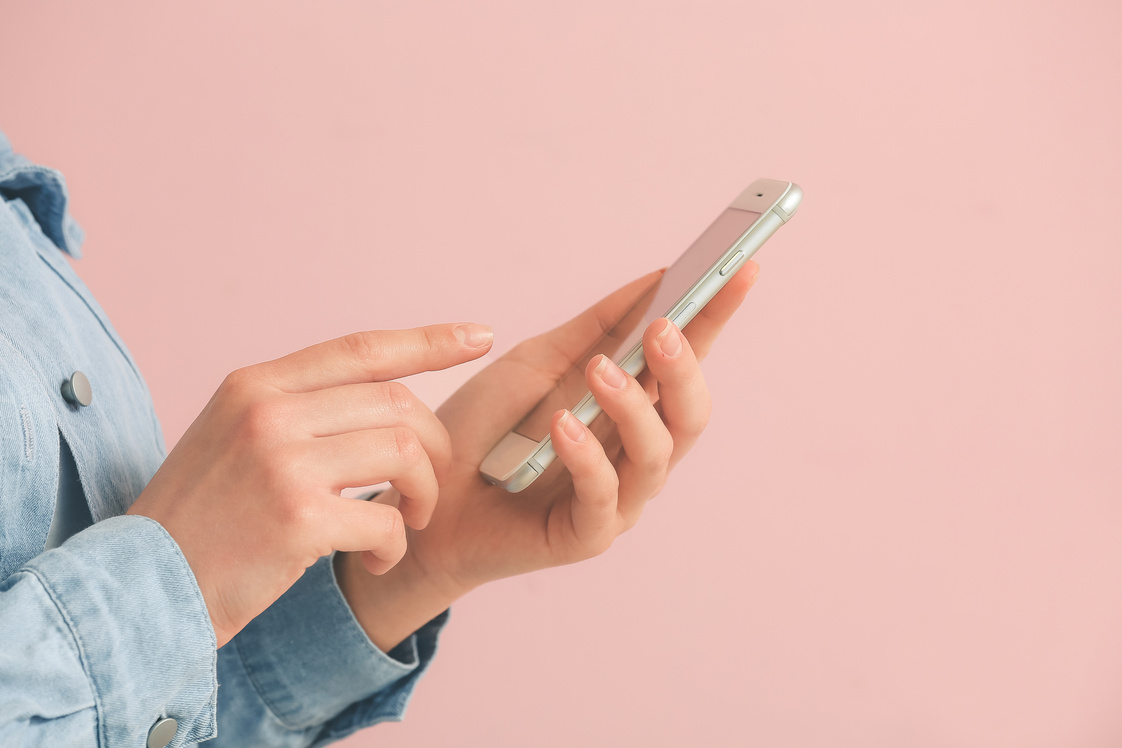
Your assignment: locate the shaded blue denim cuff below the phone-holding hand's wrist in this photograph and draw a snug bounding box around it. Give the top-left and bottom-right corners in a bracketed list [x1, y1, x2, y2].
[232, 556, 448, 739]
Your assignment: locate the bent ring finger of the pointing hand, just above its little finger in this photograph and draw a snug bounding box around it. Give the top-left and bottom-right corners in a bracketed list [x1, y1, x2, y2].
[312, 426, 440, 529]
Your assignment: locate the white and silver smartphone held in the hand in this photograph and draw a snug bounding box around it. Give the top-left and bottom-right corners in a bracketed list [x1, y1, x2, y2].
[479, 179, 802, 493]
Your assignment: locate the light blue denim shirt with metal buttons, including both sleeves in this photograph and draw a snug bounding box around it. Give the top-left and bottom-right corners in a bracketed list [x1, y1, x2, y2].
[0, 135, 447, 748]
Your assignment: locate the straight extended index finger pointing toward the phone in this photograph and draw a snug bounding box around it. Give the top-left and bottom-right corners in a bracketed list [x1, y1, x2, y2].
[259, 324, 493, 393]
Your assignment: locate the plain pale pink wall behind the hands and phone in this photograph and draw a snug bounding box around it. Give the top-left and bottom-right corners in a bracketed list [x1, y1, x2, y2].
[0, 0, 1122, 748]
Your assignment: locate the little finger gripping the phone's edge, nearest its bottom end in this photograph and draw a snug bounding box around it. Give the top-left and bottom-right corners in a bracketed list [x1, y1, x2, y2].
[550, 410, 619, 556]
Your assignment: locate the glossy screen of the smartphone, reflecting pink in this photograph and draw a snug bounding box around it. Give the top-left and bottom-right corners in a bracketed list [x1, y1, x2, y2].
[514, 207, 760, 442]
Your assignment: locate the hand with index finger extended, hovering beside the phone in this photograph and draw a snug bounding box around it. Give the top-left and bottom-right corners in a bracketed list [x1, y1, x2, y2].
[129, 324, 491, 646]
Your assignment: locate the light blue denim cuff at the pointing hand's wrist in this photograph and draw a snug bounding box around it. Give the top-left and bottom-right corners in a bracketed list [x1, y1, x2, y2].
[24, 515, 218, 746]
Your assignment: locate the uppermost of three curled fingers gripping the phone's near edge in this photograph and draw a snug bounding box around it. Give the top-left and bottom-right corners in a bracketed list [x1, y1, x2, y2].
[643, 318, 712, 465]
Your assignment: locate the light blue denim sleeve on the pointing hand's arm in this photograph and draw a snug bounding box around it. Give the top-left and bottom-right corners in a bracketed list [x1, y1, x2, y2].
[0, 516, 217, 748]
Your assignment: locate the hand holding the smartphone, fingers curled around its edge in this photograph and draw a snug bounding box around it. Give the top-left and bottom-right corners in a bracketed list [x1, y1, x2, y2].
[335, 261, 758, 650]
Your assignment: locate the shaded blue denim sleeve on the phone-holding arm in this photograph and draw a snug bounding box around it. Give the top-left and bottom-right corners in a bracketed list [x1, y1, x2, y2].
[206, 556, 448, 748]
